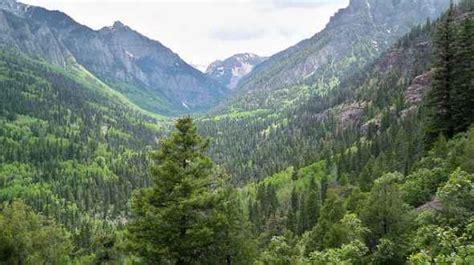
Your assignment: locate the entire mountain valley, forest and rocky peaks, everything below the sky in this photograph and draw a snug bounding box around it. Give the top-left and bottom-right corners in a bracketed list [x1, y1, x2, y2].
[0, 0, 474, 265]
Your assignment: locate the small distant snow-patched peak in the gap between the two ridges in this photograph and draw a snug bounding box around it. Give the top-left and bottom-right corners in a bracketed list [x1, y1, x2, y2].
[206, 53, 267, 90]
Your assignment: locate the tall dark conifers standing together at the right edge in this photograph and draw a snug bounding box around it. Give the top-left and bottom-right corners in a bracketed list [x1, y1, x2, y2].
[426, 3, 474, 148]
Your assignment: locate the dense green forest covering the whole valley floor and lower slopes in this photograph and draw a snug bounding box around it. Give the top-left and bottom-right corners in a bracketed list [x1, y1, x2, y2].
[0, 0, 474, 265]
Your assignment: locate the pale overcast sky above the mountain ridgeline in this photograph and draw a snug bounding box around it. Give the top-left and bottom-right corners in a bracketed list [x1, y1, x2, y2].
[19, 0, 349, 67]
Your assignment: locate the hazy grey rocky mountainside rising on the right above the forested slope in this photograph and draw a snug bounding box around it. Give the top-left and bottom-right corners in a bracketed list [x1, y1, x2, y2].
[219, 0, 450, 110]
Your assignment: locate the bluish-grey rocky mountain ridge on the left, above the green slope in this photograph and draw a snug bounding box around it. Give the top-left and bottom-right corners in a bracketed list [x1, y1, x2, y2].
[0, 0, 227, 115]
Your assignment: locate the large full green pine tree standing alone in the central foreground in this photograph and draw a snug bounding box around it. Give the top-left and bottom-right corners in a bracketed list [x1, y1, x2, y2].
[127, 118, 251, 264]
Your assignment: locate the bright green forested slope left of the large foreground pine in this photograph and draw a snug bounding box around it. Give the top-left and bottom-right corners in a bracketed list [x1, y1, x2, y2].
[0, 48, 165, 252]
